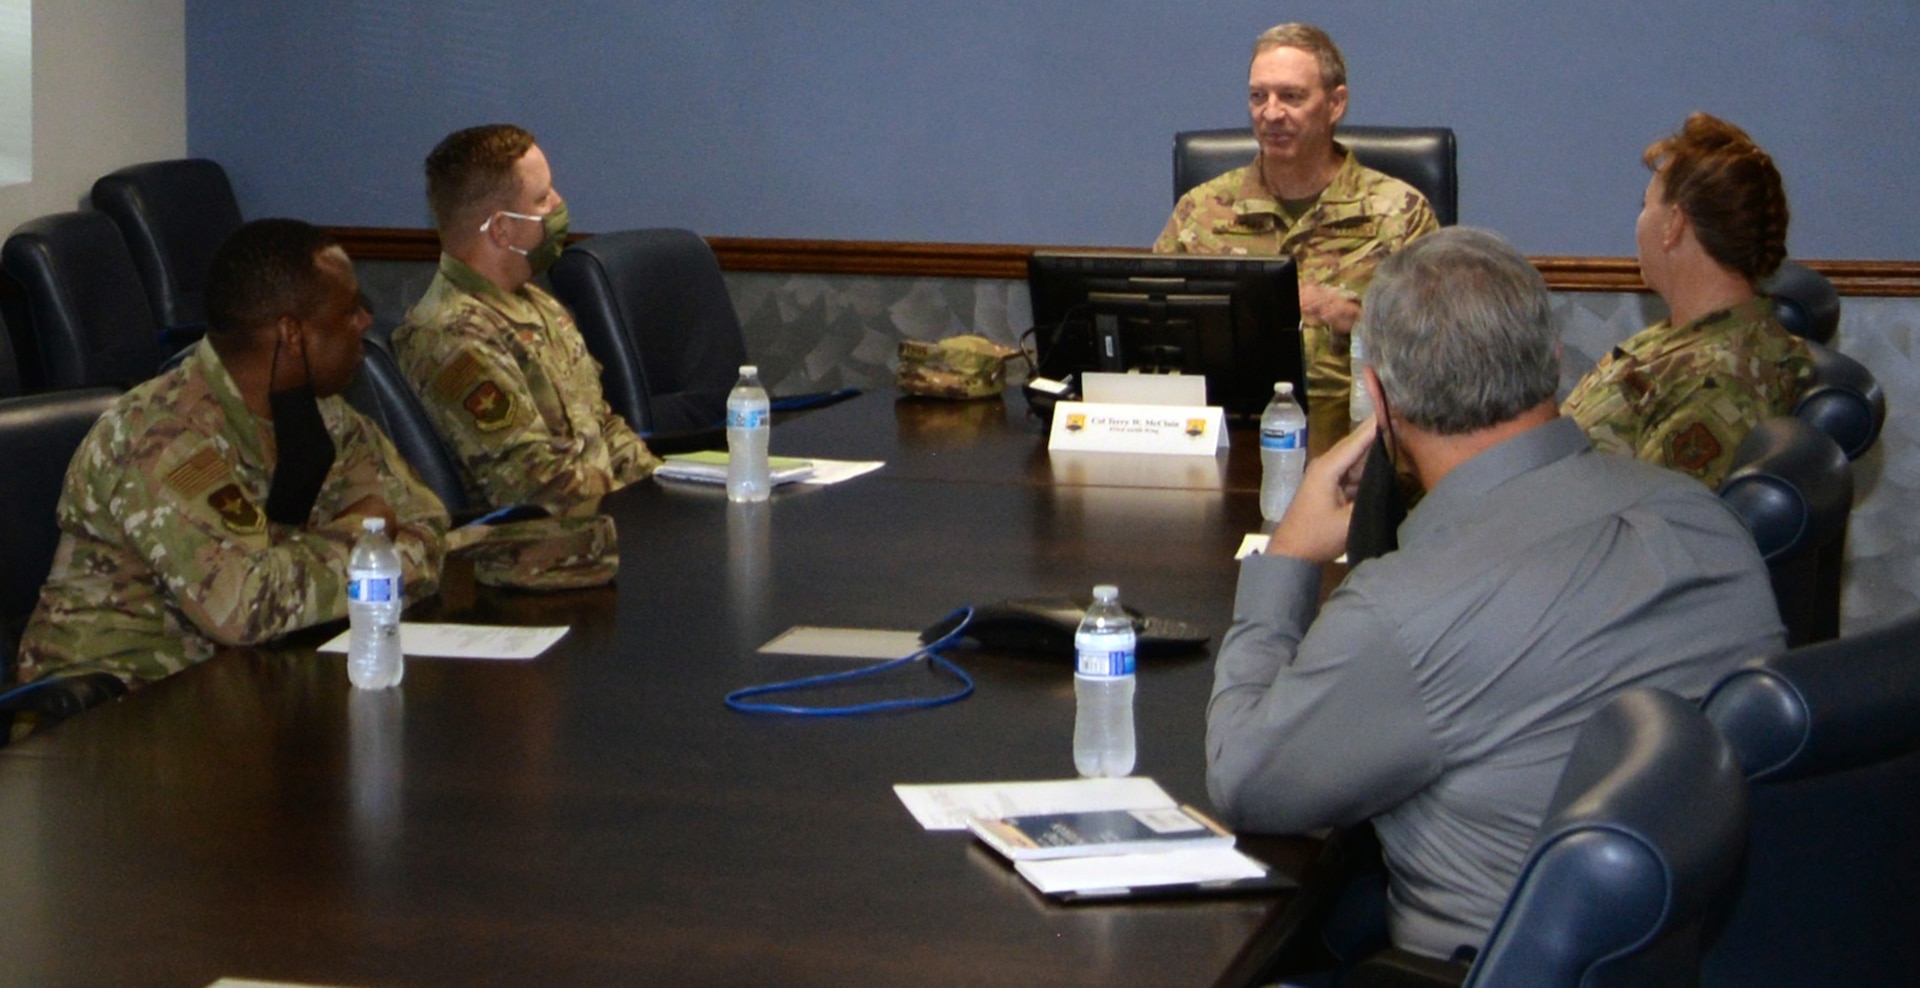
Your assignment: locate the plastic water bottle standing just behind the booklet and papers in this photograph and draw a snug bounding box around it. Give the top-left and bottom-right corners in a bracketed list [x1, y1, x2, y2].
[1073, 583, 1135, 777]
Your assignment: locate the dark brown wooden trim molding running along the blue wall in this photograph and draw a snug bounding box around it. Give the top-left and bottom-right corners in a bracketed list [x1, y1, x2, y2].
[332, 226, 1920, 297]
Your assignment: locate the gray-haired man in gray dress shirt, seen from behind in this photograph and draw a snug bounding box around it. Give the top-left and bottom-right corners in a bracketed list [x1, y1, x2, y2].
[1208, 228, 1786, 957]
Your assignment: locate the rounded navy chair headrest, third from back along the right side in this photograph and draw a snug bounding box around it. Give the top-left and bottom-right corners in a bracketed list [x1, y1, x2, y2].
[1720, 416, 1853, 564]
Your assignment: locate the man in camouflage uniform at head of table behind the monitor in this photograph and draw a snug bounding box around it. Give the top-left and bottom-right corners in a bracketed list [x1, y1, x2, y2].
[1154, 23, 1440, 453]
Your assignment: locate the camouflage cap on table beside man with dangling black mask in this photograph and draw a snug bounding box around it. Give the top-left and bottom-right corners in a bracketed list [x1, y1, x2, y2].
[447, 514, 620, 591]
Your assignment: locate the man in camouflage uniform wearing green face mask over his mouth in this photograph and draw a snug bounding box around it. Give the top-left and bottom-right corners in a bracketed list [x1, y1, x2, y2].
[394, 125, 660, 516]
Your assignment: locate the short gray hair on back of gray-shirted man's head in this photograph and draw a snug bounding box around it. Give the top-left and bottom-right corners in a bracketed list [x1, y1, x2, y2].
[1354, 226, 1559, 435]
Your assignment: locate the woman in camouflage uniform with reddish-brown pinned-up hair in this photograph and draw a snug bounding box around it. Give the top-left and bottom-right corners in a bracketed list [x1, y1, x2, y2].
[1563, 113, 1812, 489]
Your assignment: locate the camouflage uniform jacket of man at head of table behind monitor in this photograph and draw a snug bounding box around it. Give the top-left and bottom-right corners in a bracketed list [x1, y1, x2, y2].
[1154, 142, 1440, 449]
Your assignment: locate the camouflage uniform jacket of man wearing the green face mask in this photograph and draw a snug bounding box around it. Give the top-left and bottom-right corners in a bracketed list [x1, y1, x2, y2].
[394, 253, 660, 514]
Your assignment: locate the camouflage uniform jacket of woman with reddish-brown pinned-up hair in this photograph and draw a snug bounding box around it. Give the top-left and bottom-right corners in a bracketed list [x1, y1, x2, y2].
[1561, 297, 1812, 489]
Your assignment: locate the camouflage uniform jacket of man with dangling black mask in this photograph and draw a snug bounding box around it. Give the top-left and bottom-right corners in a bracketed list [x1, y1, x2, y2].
[21, 345, 447, 685]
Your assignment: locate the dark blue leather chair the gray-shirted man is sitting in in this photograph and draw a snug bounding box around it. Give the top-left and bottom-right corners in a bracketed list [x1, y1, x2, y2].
[1340, 691, 1747, 988]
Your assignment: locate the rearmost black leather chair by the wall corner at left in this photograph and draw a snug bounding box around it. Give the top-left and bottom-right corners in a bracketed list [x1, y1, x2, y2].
[92, 157, 240, 349]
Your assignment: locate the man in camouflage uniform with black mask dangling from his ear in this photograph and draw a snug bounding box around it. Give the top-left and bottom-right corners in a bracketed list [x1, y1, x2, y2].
[19, 219, 447, 687]
